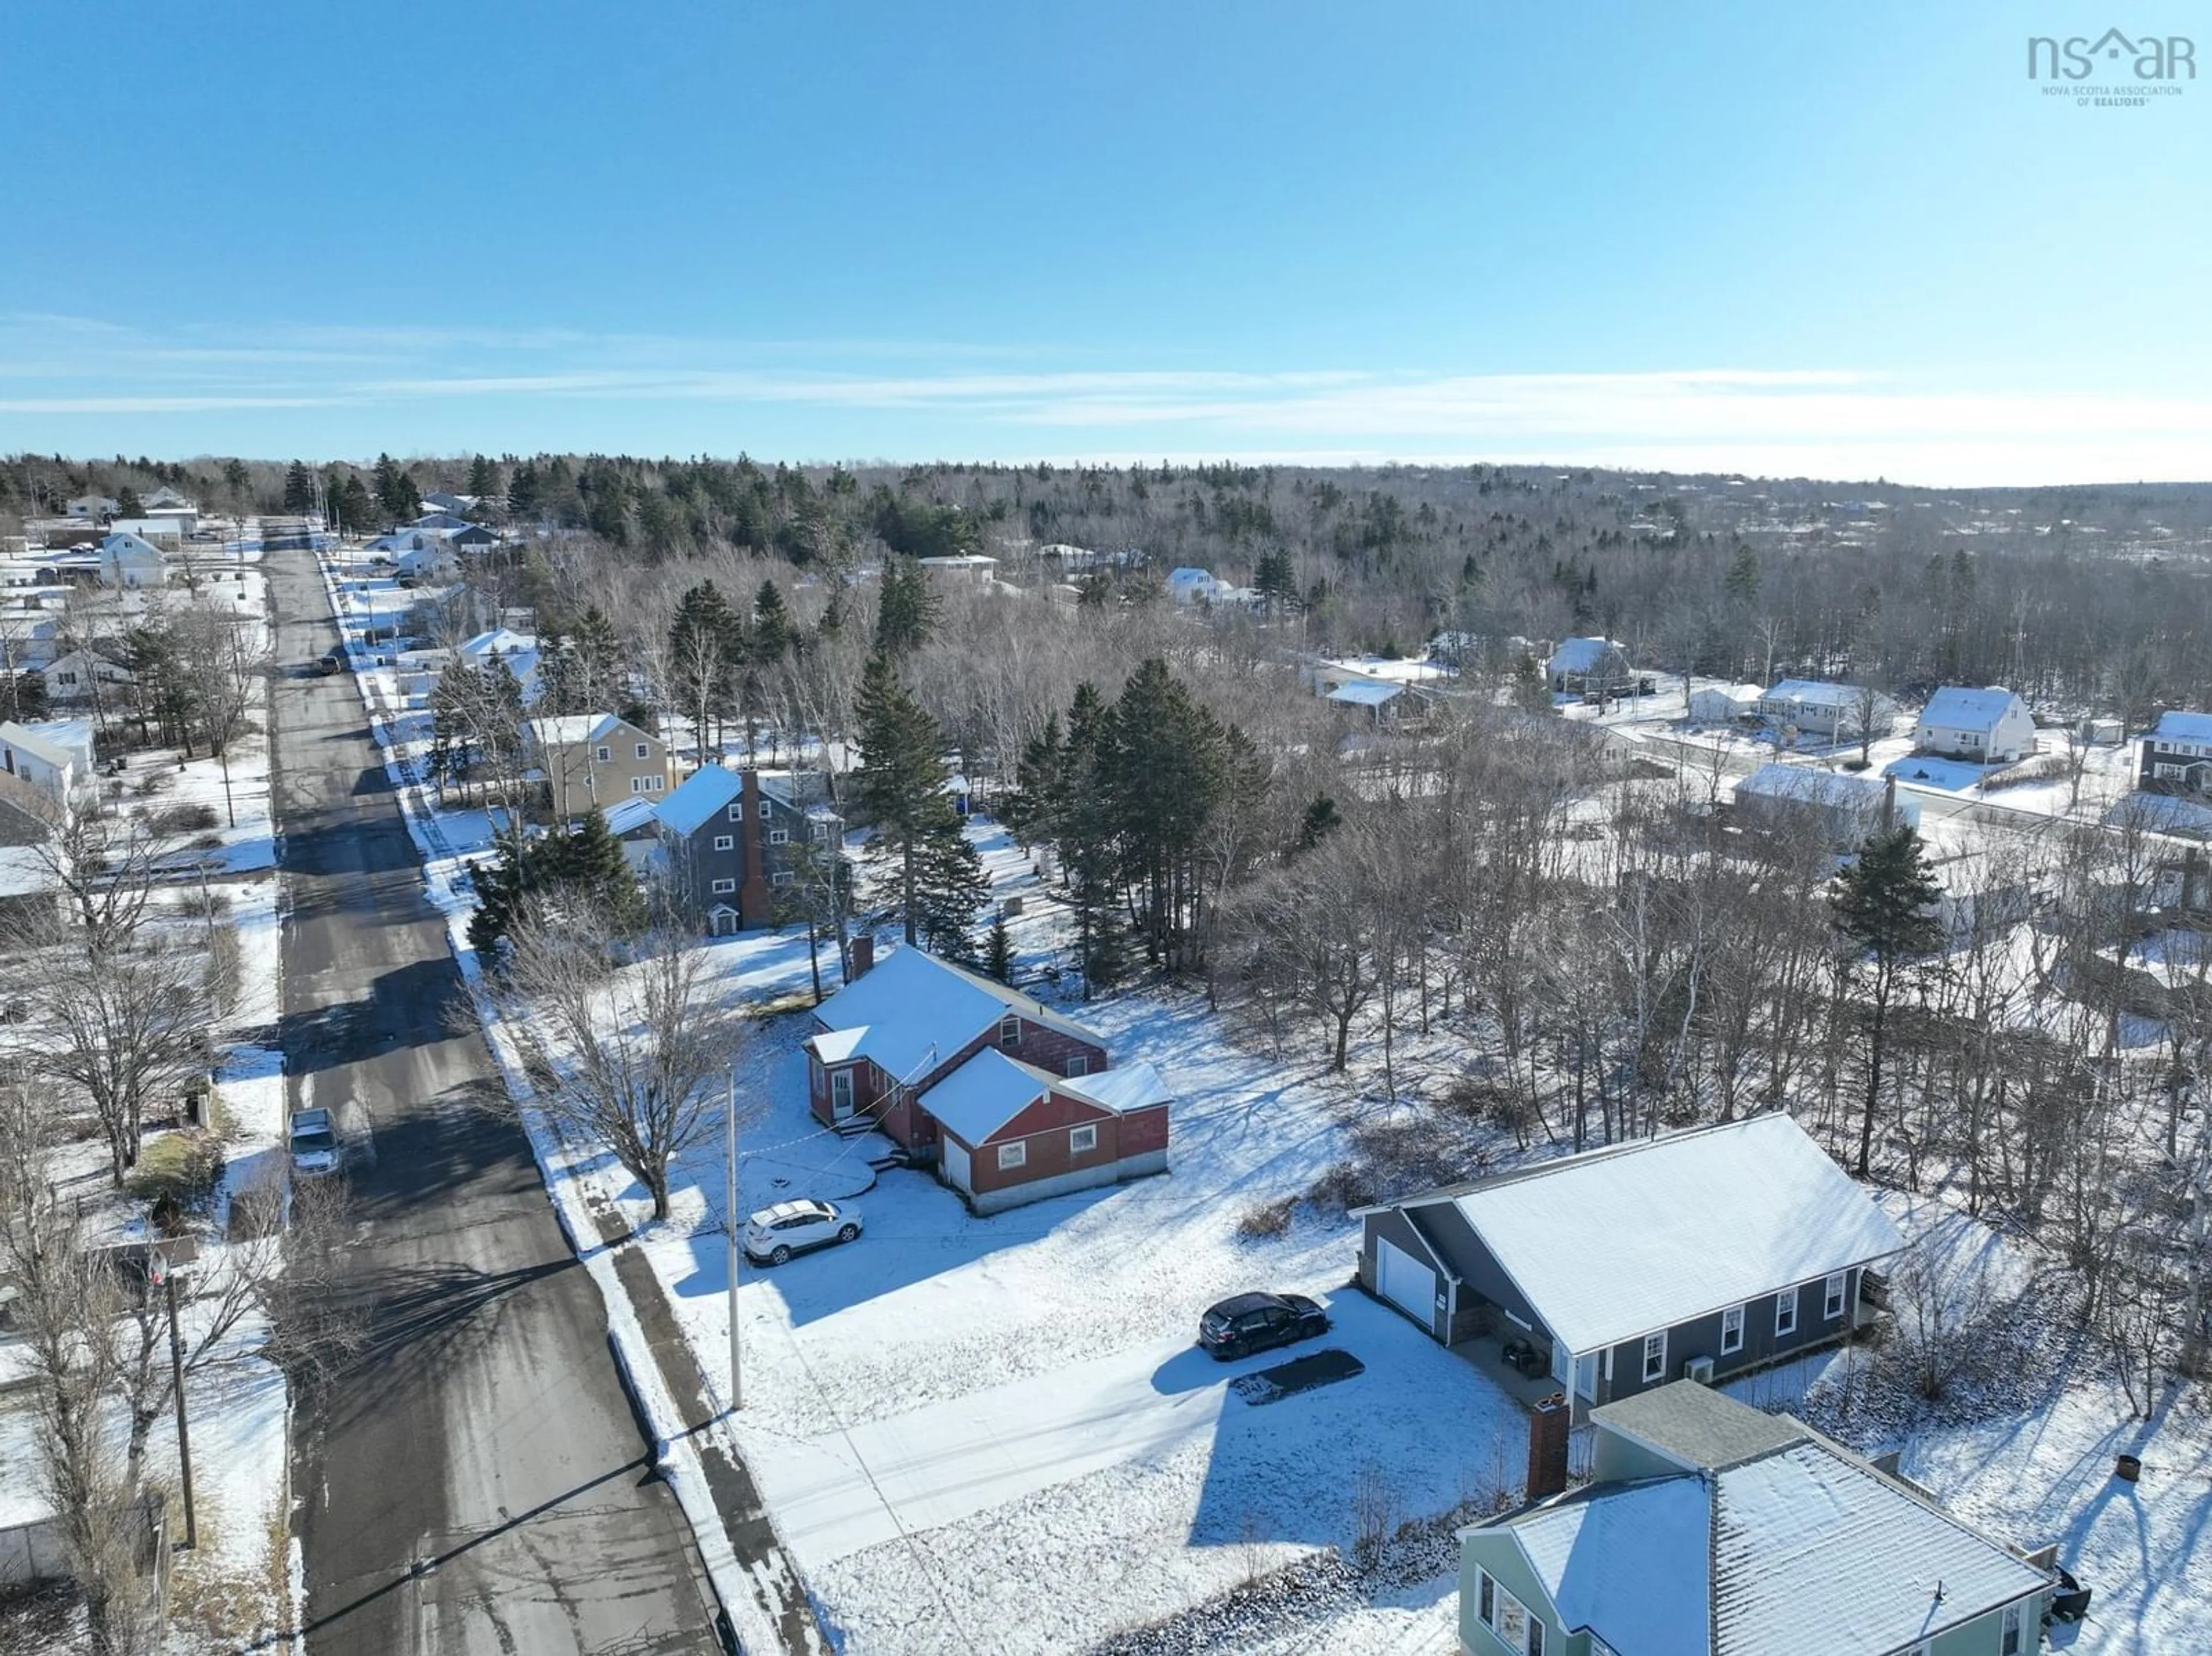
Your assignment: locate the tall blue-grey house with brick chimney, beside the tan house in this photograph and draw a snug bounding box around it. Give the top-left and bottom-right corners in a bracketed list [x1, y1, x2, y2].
[655, 765, 843, 938]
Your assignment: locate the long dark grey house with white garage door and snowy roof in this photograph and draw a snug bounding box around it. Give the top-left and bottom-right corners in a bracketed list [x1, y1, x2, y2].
[1358, 1112, 1904, 1404]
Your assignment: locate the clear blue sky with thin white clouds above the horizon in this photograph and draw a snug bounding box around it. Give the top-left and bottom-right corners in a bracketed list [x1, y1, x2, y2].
[0, 0, 2212, 484]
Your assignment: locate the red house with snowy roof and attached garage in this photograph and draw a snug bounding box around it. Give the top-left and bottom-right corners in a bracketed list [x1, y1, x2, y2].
[805, 939, 1172, 1214]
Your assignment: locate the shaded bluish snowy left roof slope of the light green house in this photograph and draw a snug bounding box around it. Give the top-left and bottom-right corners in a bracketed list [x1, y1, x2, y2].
[1511, 1477, 1712, 1656]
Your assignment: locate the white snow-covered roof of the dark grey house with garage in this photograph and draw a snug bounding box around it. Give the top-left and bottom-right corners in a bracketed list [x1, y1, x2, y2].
[1433, 1115, 1904, 1353]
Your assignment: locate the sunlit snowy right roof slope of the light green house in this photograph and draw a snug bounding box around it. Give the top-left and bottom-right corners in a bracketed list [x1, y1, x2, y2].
[1683, 1442, 2051, 1656]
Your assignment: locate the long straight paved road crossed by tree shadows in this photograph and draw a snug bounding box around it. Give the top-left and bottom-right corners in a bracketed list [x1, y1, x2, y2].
[268, 533, 719, 1656]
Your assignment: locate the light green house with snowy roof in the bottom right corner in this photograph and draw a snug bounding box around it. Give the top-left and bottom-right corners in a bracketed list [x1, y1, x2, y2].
[1460, 1382, 2057, 1656]
